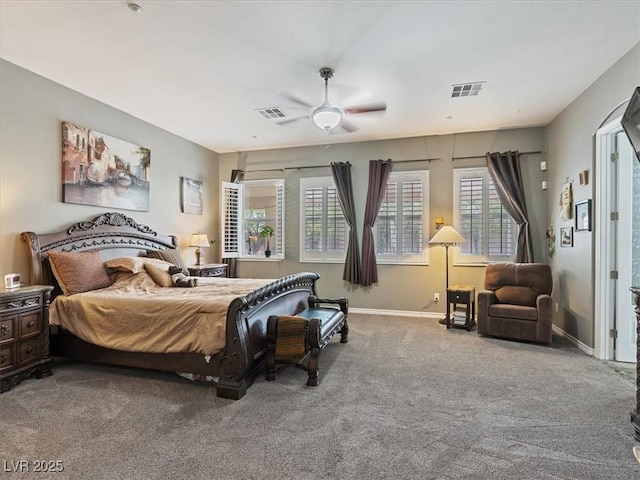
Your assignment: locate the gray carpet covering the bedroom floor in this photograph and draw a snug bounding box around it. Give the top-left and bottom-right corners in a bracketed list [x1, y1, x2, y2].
[0, 314, 640, 480]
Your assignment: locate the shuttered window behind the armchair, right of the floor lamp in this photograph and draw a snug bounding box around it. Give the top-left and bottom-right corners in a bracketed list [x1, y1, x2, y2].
[453, 167, 516, 263]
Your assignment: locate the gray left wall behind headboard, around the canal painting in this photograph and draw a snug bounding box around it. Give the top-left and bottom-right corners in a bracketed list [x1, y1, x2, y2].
[0, 60, 219, 280]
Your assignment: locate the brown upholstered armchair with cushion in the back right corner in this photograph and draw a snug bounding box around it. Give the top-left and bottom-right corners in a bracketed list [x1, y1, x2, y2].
[478, 263, 553, 343]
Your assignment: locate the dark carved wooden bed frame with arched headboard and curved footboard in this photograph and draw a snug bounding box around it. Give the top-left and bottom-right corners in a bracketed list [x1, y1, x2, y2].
[21, 212, 319, 400]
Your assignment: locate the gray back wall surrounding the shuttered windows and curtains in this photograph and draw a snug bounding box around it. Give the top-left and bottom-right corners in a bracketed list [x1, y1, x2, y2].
[220, 127, 547, 313]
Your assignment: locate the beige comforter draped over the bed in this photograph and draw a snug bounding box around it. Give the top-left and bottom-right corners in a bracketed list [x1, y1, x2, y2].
[49, 272, 273, 355]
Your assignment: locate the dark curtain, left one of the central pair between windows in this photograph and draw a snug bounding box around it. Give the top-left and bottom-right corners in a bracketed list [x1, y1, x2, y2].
[331, 162, 362, 285]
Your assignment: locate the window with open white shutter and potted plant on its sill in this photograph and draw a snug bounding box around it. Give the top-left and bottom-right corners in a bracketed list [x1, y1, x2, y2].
[220, 180, 284, 259]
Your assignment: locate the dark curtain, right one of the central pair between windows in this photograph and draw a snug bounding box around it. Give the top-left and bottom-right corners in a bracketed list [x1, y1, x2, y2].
[360, 160, 392, 287]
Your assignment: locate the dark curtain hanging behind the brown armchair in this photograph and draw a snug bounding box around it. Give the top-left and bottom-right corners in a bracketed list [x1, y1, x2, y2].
[487, 150, 533, 263]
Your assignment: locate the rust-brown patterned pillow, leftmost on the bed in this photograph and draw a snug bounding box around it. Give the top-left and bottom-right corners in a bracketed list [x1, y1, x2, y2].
[49, 250, 111, 295]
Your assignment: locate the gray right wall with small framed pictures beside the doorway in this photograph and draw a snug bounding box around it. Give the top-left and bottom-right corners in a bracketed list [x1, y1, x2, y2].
[547, 44, 640, 347]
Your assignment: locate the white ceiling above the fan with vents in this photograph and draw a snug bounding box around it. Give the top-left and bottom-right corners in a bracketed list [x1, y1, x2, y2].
[0, 0, 640, 153]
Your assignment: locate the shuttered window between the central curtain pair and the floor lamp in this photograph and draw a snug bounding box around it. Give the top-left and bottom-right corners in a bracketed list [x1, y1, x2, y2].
[374, 171, 429, 264]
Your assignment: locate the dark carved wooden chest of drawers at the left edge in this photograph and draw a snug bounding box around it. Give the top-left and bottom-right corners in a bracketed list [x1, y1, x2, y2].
[0, 285, 53, 393]
